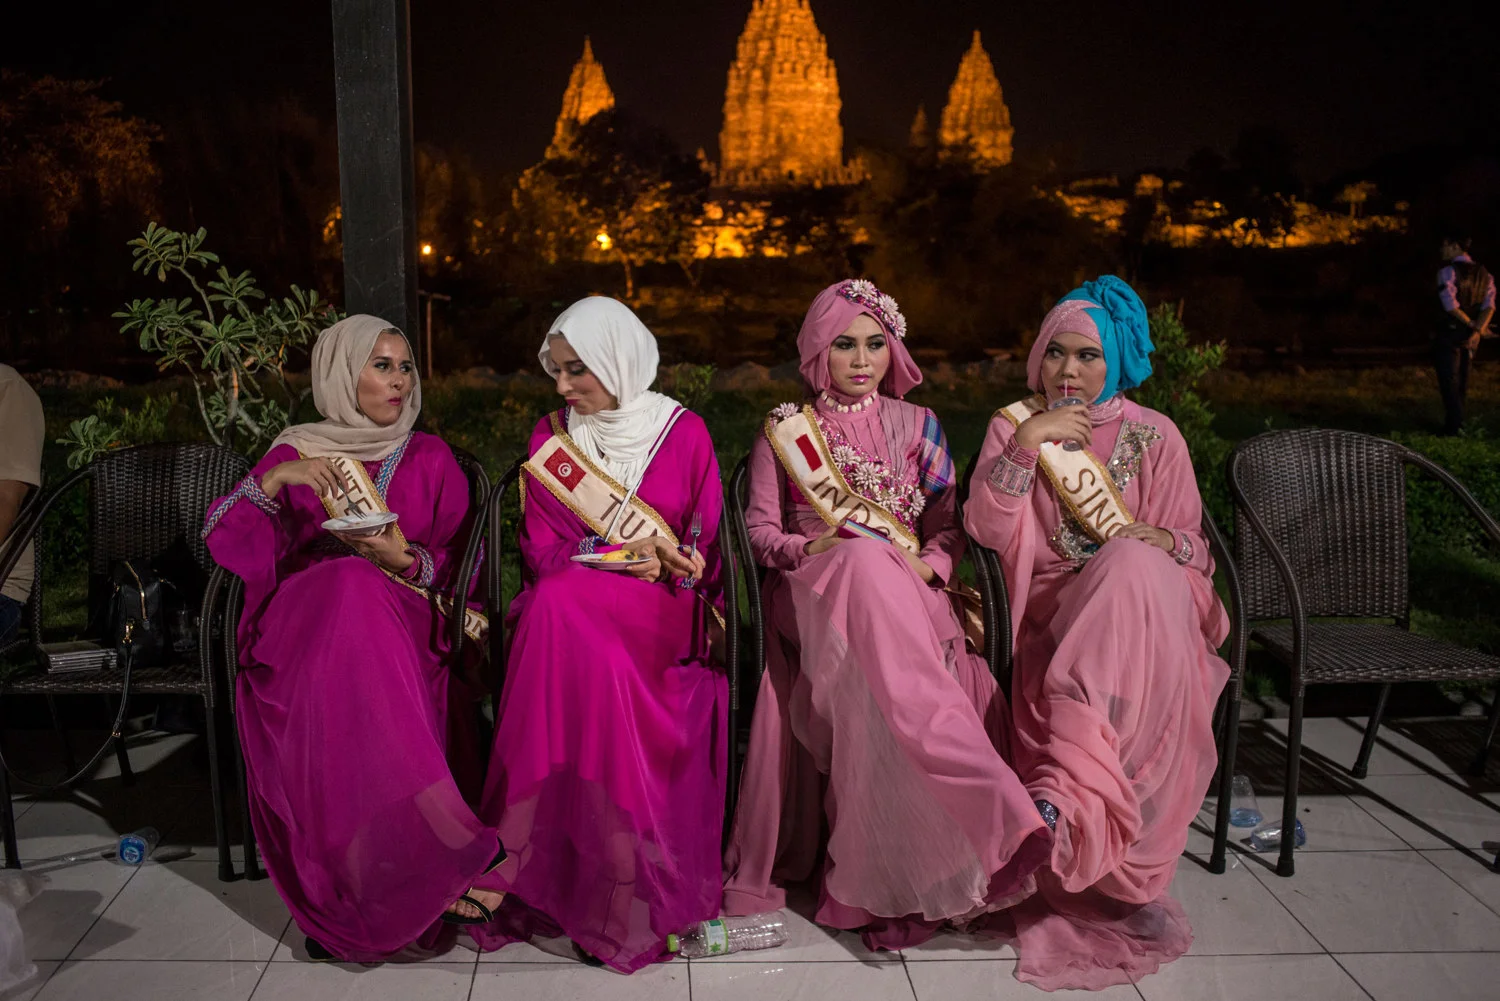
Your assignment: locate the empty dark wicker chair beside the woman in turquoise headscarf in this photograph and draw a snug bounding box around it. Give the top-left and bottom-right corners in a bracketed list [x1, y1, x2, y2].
[1227, 429, 1500, 876]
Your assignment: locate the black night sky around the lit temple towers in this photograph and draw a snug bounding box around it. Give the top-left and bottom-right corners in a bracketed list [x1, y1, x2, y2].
[0, 0, 1500, 180]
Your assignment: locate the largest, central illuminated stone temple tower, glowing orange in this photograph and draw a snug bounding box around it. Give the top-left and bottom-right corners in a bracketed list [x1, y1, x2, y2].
[719, 0, 863, 189]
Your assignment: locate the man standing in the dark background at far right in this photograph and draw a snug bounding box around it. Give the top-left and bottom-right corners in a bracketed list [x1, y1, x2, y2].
[1433, 237, 1496, 435]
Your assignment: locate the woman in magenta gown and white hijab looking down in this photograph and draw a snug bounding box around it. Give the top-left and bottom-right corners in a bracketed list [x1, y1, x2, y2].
[471, 299, 729, 972]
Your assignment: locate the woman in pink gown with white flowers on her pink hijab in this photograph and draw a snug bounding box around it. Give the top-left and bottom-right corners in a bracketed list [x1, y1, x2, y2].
[725, 281, 1049, 948]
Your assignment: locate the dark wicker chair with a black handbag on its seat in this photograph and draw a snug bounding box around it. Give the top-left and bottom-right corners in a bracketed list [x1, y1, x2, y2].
[0, 443, 251, 879]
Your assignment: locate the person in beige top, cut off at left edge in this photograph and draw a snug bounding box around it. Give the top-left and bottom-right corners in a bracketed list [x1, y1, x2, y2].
[0, 365, 47, 647]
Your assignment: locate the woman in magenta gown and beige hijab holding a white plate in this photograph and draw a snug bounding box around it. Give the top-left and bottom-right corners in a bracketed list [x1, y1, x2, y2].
[204, 315, 503, 962]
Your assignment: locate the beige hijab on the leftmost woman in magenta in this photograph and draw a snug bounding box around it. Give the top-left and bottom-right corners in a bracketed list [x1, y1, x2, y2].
[272, 314, 422, 462]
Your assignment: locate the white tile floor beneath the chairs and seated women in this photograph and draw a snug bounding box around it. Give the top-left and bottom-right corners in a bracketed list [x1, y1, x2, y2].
[0, 719, 1500, 1001]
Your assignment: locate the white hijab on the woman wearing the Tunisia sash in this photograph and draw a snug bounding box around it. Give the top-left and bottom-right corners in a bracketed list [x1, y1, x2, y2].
[537, 296, 681, 489]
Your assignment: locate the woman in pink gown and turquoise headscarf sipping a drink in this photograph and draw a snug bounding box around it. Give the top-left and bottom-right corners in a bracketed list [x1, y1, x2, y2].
[965, 276, 1229, 990]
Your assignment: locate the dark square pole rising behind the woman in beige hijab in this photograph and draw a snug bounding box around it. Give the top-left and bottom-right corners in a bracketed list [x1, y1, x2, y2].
[333, 0, 422, 364]
